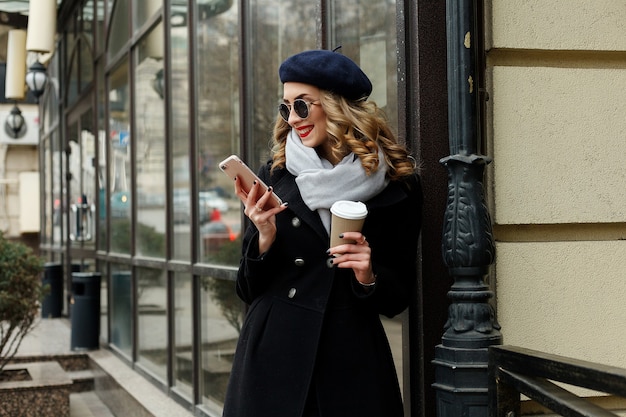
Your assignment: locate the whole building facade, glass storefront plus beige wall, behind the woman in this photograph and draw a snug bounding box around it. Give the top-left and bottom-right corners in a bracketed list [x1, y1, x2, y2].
[0, 0, 626, 416]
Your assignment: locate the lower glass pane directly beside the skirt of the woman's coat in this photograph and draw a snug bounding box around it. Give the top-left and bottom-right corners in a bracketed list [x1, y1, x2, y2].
[200, 277, 243, 415]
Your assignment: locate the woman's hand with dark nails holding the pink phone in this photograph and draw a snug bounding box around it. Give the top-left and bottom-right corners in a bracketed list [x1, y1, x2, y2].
[235, 178, 287, 254]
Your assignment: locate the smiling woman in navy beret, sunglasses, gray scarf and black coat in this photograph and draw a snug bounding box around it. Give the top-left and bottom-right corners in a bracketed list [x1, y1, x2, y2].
[224, 50, 422, 417]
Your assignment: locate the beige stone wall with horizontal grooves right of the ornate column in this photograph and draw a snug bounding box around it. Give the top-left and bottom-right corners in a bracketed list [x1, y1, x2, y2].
[486, 0, 626, 368]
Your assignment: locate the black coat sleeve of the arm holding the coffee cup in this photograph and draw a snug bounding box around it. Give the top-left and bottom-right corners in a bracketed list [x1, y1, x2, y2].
[354, 176, 423, 317]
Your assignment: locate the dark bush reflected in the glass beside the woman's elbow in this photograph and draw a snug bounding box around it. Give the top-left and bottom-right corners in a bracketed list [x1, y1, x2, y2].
[200, 238, 243, 332]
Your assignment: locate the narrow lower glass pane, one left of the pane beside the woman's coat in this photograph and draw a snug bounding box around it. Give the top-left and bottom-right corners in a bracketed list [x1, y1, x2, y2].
[172, 273, 194, 400]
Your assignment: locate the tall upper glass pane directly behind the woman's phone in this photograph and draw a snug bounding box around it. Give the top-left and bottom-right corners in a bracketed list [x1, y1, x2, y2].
[195, 1, 241, 265]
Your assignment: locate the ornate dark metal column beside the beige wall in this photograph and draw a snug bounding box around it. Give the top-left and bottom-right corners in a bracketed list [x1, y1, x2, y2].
[433, 0, 502, 417]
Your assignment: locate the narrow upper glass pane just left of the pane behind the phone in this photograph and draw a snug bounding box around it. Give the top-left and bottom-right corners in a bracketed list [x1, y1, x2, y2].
[169, 1, 191, 261]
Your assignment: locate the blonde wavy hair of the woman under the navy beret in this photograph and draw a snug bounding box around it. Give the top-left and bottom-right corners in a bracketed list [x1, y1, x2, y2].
[272, 90, 416, 180]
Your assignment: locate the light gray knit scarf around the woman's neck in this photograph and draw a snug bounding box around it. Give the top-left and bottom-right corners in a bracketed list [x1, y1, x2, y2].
[285, 129, 389, 233]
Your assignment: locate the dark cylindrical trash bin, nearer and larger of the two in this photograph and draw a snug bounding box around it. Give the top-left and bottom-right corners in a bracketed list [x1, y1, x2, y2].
[70, 272, 101, 350]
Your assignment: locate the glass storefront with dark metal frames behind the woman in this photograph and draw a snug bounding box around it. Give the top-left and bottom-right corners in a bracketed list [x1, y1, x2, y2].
[36, 0, 414, 416]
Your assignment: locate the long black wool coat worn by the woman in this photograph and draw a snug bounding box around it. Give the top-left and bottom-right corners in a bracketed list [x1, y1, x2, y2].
[223, 165, 422, 417]
